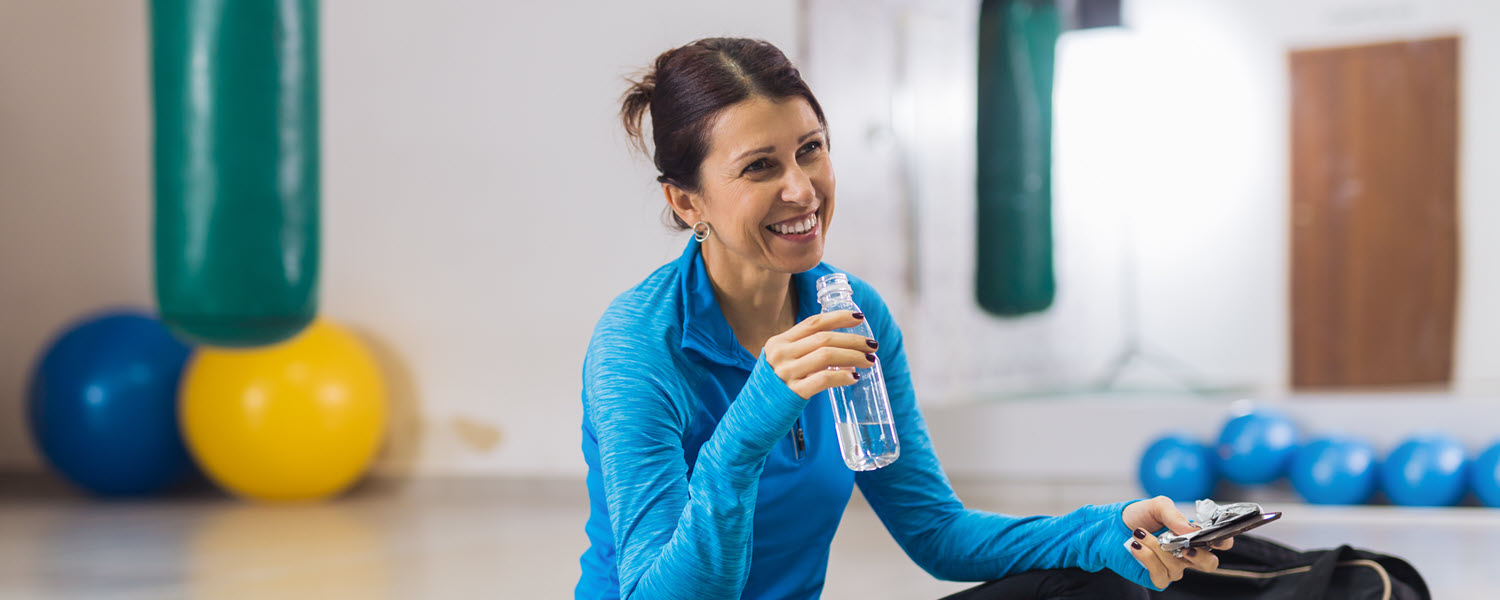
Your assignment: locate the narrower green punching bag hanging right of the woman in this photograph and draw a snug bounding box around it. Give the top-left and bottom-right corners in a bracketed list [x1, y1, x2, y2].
[975, 0, 1062, 317]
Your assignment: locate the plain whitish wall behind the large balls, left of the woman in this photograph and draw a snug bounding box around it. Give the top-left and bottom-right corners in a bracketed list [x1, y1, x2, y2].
[0, 0, 797, 474]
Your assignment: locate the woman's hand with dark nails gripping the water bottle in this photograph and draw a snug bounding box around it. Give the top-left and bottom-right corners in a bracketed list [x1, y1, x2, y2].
[765, 311, 878, 401]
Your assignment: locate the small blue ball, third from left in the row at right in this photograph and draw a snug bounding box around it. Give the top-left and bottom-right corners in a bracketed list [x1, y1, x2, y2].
[1289, 437, 1379, 504]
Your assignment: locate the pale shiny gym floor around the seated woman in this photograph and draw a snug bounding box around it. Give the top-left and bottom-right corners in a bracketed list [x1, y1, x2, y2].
[0, 477, 1500, 600]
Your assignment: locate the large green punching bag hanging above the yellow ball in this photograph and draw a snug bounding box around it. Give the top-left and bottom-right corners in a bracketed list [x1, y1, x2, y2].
[152, 0, 318, 347]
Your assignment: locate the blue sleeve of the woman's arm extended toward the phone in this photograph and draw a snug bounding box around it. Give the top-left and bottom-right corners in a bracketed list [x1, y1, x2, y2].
[855, 287, 1157, 590]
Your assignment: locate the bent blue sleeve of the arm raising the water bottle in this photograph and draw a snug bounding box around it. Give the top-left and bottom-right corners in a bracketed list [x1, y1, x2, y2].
[584, 340, 807, 599]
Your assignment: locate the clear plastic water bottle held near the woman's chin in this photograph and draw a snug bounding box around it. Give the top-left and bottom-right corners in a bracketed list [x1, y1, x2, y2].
[818, 273, 902, 471]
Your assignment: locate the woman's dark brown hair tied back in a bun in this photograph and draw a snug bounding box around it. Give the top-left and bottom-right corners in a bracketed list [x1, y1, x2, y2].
[620, 38, 828, 230]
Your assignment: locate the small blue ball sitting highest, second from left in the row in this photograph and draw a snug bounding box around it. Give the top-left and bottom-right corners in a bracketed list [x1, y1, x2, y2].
[1218, 411, 1298, 486]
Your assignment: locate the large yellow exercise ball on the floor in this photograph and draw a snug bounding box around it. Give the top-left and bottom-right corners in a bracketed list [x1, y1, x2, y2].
[179, 320, 386, 501]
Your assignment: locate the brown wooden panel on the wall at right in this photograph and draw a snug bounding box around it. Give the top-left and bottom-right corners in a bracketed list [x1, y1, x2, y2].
[1290, 38, 1458, 387]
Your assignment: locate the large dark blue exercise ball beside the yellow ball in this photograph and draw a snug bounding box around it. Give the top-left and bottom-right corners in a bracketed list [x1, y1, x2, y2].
[27, 311, 194, 497]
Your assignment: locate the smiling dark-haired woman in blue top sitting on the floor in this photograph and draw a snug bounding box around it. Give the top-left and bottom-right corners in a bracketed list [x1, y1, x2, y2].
[575, 39, 1227, 599]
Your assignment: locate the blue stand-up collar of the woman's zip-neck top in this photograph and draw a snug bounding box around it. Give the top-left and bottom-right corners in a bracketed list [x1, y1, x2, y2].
[677, 239, 834, 371]
